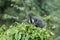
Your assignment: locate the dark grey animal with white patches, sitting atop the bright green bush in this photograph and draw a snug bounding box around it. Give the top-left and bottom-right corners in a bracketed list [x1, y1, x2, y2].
[27, 15, 45, 28]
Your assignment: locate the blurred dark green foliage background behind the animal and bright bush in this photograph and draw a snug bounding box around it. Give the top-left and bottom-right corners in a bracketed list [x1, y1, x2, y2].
[0, 0, 60, 40]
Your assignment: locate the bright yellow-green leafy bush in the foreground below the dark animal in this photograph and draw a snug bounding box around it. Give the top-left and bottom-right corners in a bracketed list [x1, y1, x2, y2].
[0, 23, 50, 40]
